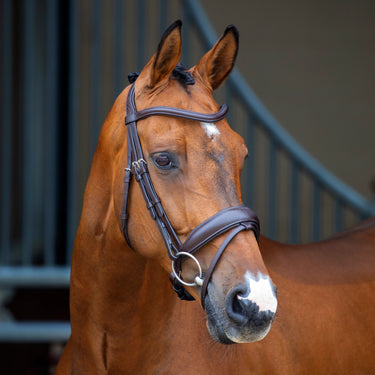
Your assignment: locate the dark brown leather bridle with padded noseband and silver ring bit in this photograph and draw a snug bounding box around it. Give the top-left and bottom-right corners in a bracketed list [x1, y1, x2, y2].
[121, 83, 260, 308]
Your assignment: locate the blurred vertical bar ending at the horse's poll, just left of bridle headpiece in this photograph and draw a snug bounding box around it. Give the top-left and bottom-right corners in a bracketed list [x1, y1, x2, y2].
[113, 0, 125, 99]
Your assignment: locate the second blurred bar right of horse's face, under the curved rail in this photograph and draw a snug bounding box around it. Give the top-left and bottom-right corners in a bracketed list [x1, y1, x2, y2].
[267, 137, 277, 239]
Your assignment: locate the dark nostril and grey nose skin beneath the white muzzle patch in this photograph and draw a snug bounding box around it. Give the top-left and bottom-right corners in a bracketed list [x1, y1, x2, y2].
[225, 286, 275, 327]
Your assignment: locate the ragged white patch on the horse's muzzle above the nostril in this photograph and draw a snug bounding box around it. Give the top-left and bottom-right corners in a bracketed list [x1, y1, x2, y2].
[237, 272, 277, 313]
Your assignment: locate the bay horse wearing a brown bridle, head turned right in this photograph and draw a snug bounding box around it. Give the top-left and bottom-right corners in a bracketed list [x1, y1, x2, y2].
[56, 21, 375, 375]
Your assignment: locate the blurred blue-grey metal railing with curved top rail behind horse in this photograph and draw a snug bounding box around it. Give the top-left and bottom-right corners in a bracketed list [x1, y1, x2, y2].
[0, 0, 374, 341]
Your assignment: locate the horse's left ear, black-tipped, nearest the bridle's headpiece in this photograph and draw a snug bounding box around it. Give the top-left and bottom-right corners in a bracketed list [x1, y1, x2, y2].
[139, 20, 182, 88]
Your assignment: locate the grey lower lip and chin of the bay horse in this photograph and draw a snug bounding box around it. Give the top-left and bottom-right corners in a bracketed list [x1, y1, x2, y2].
[205, 288, 271, 345]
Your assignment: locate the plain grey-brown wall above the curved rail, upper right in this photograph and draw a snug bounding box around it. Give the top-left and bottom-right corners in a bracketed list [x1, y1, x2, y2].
[201, 0, 375, 198]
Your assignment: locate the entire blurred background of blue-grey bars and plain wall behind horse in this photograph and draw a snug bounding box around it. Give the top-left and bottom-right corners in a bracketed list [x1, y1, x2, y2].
[0, 0, 375, 374]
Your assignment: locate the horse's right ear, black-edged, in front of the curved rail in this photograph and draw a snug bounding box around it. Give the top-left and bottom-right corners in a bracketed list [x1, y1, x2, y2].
[196, 25, 239, 90]
